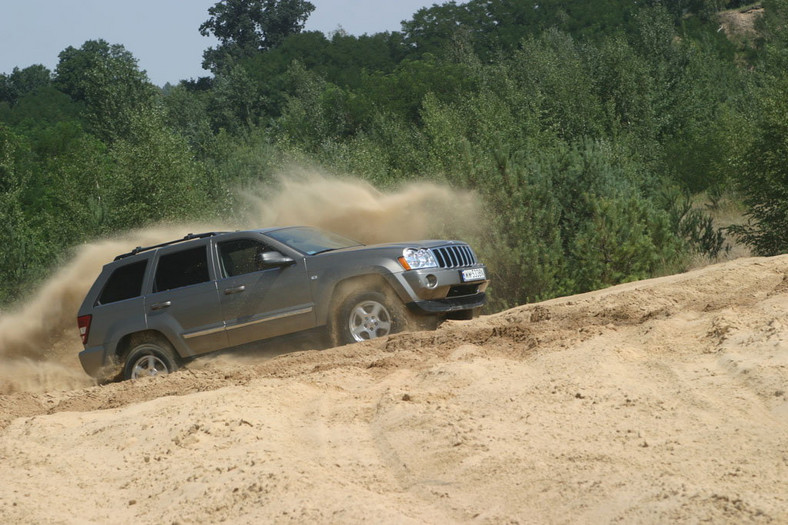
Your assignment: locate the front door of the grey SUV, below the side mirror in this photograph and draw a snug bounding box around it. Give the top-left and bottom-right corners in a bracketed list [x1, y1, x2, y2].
[217, 237, 315, 346]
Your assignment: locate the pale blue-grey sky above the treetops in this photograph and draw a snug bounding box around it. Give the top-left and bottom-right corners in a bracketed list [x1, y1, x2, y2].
[0, 0, 450, 86]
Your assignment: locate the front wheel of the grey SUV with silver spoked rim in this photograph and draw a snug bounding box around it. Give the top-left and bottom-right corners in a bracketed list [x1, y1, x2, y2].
[331, 292, 408, 345]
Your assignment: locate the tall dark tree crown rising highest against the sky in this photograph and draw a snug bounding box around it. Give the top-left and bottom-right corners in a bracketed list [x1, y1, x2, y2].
[200, 0, 315, 73]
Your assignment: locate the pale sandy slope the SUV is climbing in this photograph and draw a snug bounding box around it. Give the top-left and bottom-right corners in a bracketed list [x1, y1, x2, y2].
[0, 256, 788, 524]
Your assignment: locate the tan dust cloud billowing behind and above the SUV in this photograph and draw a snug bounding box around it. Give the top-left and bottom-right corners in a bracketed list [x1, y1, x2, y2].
[0, 170, 480, 394]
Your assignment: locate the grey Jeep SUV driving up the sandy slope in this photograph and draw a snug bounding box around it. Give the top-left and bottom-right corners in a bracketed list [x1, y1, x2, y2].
[78, 227, 489, 379]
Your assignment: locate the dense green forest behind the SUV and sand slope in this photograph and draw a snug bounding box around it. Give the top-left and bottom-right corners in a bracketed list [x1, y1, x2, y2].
[0, 0, 788, 311]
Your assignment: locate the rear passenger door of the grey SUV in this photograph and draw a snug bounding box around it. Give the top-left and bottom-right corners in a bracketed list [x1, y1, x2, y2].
[145, 242, 229, 356]
